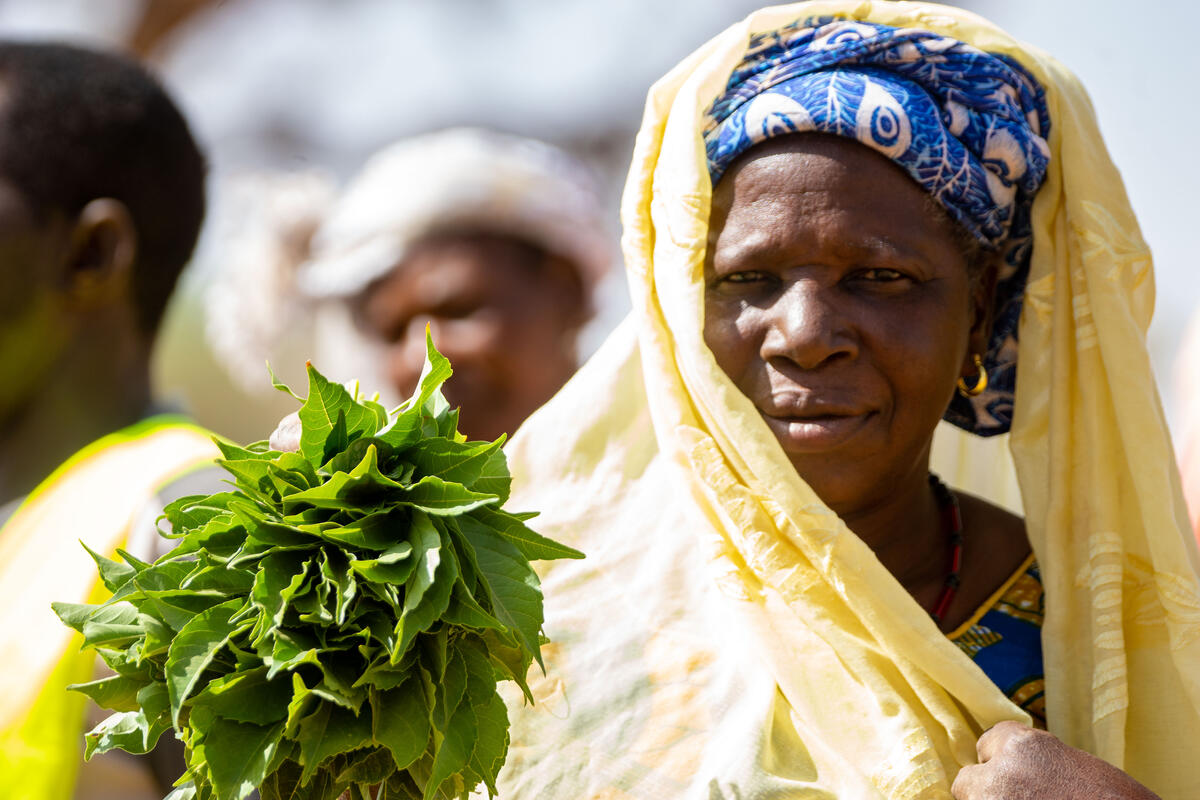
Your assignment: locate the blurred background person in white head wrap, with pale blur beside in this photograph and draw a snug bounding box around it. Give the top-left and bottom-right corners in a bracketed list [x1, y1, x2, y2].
[206, 128, 614, 439]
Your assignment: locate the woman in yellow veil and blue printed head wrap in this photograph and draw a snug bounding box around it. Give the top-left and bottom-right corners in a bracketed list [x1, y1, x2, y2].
[500, 0, 1200, 800]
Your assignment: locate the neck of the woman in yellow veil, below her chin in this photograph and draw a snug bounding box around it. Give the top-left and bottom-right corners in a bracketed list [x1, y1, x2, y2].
[841, 459, 948, 602]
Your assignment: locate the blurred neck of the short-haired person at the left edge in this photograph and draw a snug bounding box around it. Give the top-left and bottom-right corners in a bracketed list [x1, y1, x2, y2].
[0, 320, 150, 504]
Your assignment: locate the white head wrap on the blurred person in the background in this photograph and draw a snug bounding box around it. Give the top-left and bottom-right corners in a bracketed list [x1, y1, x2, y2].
[299, 128, 613, 297]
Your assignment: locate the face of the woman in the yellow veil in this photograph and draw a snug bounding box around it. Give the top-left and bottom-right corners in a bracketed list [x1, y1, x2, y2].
[704, 134, 990, 517]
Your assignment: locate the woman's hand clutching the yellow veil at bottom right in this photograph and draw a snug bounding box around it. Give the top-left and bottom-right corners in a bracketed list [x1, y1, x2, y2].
[950, 722, 1159, 800]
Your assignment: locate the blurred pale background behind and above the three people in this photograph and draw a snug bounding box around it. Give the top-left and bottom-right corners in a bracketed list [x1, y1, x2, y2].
[0, 0, 1200, 440]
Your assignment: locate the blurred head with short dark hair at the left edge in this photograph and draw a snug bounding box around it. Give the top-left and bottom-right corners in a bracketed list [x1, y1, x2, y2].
[0, 42, 204, 417]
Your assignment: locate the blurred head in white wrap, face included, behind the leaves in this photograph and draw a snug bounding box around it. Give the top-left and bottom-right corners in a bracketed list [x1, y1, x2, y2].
[300, 130, 611, 439]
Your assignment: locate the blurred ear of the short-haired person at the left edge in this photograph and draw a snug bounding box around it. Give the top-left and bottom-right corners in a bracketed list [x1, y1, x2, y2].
[62, 198, 138, 309]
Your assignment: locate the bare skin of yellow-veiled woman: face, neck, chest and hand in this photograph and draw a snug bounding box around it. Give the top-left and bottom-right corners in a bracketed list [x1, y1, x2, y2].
[704, 134, 1154, 800]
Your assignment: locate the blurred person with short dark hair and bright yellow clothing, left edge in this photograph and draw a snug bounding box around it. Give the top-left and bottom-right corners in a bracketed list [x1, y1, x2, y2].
[0, 43, 215, 800]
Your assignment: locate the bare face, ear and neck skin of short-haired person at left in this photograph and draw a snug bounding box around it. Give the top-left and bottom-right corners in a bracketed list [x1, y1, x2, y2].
[0, 178, 151, 503]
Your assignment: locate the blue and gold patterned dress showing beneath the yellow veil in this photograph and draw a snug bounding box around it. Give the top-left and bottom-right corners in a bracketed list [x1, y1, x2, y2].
[948, 555, 1046, 728]
